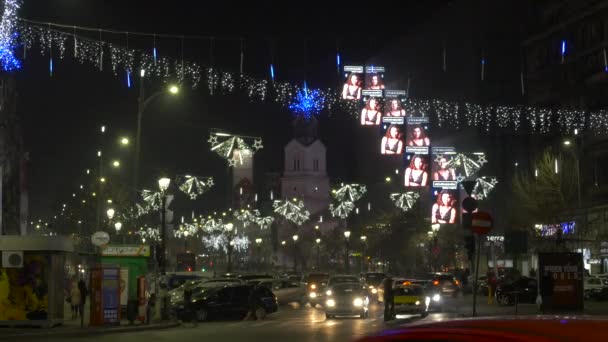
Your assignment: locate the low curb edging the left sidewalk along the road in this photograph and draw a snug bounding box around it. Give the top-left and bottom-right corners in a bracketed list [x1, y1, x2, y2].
[0, 322, 181, 341]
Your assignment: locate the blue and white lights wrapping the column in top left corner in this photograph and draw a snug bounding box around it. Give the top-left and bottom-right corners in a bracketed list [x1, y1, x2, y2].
[0, 0, 21, 71]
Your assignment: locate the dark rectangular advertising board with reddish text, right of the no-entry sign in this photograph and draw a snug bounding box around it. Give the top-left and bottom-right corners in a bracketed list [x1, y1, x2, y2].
[538, 253, 584, 312]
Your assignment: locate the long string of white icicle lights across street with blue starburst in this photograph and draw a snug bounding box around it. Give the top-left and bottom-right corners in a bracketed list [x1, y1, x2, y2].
[14, 20, 608, 135]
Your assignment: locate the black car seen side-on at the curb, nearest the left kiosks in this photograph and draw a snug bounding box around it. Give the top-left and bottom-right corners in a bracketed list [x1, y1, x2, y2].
[175, 285, 278, 321]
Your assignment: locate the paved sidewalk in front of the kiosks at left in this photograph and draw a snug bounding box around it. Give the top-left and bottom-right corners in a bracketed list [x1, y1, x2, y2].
[0, 303, 180, 340]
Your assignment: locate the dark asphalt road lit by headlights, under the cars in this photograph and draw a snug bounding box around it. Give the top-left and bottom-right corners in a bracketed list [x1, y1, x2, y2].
[25, 295, 608, 342]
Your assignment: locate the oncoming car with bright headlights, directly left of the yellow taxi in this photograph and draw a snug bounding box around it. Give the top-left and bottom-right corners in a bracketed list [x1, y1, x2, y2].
[324, 277, 369, 319]
